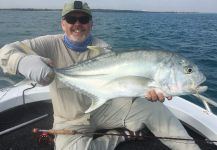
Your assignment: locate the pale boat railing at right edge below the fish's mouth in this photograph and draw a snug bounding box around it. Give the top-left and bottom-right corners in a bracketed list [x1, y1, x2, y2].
[193, 94, 217, 113]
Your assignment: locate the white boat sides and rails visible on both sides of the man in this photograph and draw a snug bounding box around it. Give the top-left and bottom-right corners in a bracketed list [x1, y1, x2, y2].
[0, 78, 217, 149]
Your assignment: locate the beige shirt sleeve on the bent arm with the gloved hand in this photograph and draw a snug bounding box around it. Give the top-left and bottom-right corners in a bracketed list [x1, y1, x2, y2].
[0, 35, 59, 74]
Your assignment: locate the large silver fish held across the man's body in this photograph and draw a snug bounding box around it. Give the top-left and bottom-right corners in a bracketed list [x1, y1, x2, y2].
[56, 50, 207, 113]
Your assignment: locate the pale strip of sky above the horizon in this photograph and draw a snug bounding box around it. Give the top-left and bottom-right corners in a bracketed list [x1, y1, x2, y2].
[0, 0, 217, 13]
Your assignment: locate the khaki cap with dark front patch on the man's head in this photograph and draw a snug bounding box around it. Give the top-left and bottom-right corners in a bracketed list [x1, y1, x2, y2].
[62, 0, 92, 17]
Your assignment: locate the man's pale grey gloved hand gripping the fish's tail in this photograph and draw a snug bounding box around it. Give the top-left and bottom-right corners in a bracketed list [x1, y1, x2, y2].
[18, 55, 55, 85]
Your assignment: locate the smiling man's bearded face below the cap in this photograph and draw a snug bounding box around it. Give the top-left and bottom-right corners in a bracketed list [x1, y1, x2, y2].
[61, 12, 92, 43]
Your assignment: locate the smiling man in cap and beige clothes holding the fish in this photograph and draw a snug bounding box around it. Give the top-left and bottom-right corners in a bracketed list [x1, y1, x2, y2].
[0, 1, 199, 150]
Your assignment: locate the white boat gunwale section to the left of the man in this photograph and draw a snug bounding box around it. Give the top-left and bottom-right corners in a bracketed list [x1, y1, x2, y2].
[0, 79, 50, 113]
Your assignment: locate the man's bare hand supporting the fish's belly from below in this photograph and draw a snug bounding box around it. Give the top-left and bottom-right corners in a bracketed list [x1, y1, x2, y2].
[145, 90, 172, 102]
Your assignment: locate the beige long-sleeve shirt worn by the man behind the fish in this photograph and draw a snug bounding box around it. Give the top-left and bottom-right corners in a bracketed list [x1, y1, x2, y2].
[0, 34, 109, 126]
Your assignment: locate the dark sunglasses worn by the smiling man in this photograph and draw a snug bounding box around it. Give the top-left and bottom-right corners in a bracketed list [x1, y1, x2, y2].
[64, 15, 91, 24]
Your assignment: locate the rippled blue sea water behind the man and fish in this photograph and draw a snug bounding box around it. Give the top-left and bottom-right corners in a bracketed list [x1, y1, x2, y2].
[0, 10, 217, 110]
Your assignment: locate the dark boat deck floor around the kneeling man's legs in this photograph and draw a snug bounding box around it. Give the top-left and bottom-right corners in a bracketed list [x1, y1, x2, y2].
[0, 102, 217, 150]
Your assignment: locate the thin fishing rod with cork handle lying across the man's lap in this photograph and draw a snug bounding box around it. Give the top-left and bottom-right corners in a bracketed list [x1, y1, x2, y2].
[32, 128, 217, 143]
